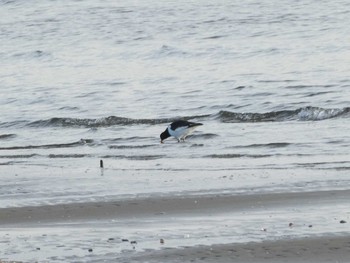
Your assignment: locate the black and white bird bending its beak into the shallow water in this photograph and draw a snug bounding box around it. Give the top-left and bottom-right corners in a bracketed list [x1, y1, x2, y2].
[160, 120, 203, 143]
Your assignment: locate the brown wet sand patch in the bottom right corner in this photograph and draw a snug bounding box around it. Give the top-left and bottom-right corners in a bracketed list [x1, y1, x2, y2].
[130, 236, 350, 263]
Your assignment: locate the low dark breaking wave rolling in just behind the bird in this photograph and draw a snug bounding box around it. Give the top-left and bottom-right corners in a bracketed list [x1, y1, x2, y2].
[0, 106, 350, 129]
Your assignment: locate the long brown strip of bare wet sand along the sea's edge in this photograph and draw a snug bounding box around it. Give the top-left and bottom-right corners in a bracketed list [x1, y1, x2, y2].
[0, 190, 350, 226]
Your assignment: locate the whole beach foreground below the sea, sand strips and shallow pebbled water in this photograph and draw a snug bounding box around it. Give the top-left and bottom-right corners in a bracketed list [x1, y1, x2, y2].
[0, 190, 350, 262]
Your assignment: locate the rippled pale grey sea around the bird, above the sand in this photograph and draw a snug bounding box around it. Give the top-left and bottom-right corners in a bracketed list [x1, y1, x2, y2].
[0, 0, 350, 260]
